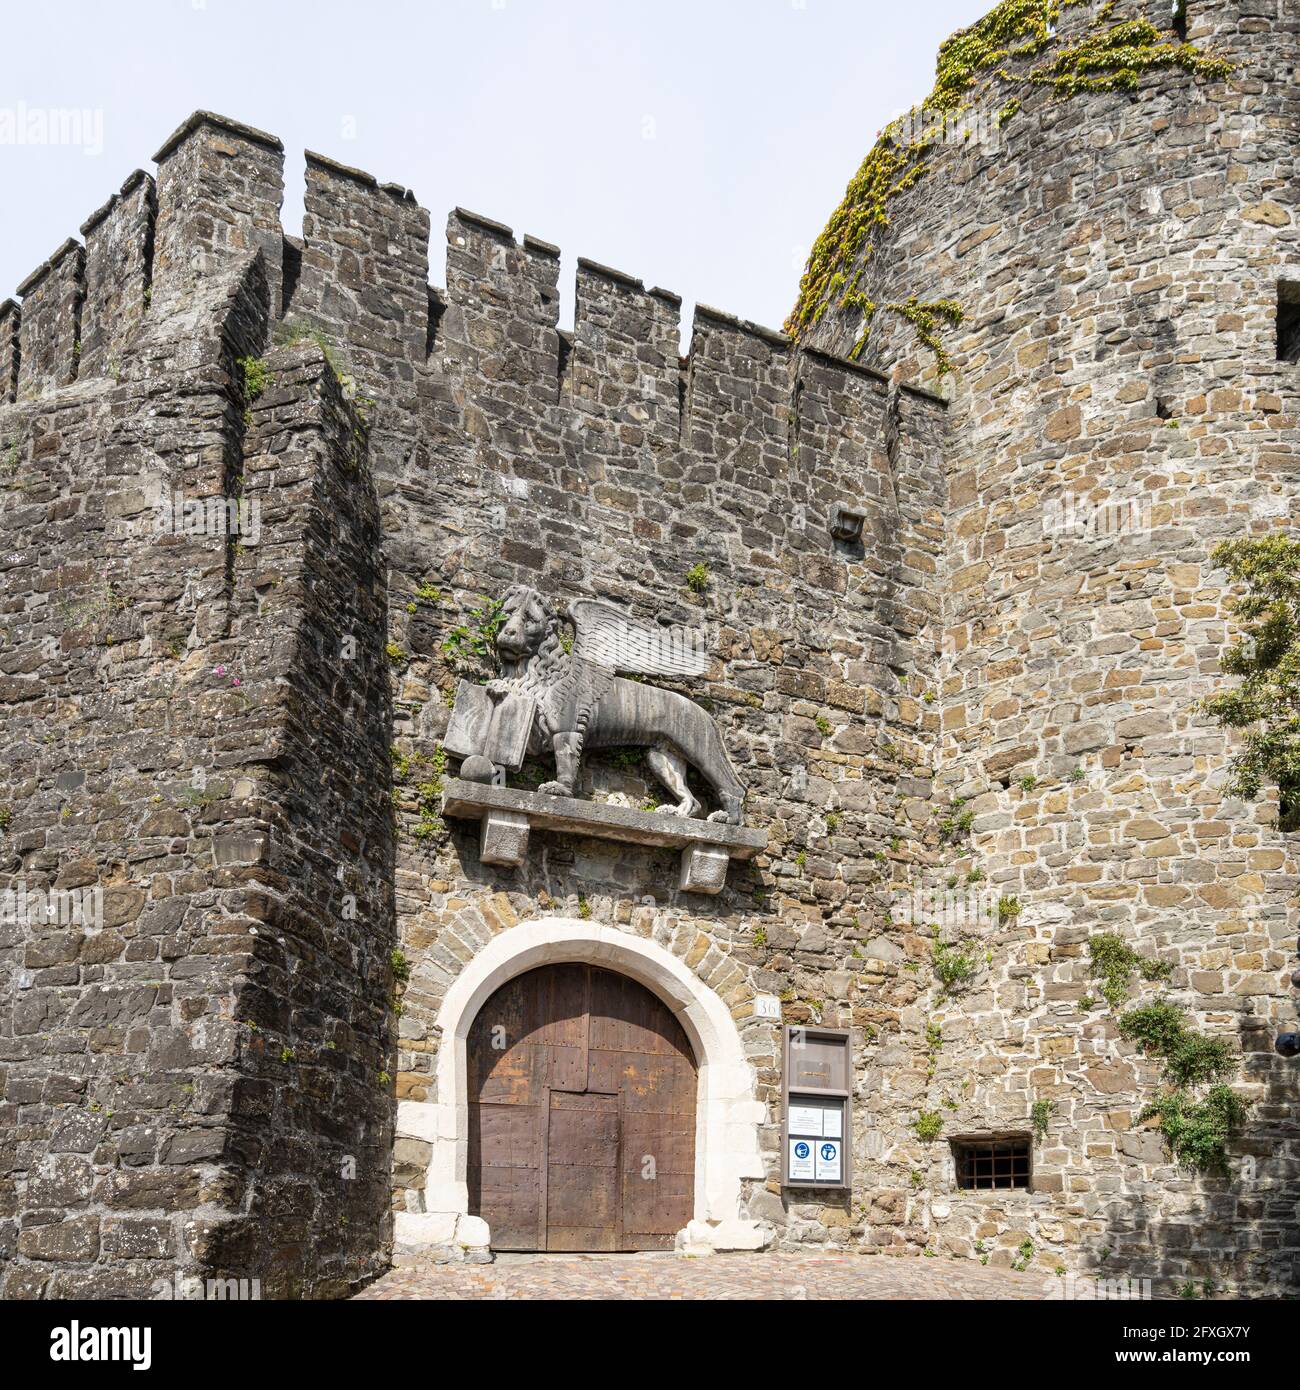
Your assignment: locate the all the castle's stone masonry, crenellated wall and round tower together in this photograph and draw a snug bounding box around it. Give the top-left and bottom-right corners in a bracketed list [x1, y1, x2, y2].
[0, 0, 1297, 1297]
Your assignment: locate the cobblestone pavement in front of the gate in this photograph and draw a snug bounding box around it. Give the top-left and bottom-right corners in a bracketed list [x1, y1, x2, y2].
[357, 1254, 1051, 1300]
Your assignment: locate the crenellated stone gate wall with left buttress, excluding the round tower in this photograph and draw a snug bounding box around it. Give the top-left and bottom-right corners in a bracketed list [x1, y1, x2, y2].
[0, 113, 945, 1295]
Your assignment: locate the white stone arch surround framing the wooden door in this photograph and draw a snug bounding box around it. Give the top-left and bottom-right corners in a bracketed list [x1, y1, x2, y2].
[393, 917, 772, 1250]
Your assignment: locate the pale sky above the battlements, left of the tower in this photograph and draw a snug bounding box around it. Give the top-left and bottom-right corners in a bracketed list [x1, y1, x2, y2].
[0, 0, 993, 336]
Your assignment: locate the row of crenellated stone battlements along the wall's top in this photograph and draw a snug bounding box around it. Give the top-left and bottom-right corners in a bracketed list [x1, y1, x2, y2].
[0, 111, 937, 483]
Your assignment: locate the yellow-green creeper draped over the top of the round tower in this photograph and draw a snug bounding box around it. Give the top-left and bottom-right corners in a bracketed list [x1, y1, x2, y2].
[786, 0, 1232, 364]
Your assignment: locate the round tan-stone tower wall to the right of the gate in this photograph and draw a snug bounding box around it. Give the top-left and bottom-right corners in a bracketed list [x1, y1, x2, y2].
[808, 0, 1300, 1294]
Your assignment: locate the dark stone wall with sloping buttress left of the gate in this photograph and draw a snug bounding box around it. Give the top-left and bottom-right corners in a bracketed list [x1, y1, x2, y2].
[0, 130, 393, 1297]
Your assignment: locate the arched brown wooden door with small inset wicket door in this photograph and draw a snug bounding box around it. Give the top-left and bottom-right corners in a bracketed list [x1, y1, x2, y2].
[466, 962, 699, 1251]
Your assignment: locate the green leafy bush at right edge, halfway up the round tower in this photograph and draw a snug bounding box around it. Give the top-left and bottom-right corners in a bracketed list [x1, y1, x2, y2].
[1201, 532, 1300, 830]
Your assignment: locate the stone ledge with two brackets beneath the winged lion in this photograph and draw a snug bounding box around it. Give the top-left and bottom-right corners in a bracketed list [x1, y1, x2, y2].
[442, 778, 767, 894]
